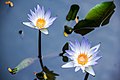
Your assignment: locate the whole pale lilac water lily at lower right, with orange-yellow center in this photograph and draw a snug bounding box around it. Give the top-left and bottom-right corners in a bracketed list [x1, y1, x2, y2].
[62, 37, 101, 76]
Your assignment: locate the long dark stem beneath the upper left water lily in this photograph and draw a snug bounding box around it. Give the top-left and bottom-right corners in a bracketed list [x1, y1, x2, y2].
[38, 30, 44, 70]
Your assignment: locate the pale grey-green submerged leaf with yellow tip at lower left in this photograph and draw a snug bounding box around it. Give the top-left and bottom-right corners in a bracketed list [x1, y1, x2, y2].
[8, 58, 37, 74]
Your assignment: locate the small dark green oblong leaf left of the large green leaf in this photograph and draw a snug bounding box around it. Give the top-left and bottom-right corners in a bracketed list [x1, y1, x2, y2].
[66, 4, 79, 21]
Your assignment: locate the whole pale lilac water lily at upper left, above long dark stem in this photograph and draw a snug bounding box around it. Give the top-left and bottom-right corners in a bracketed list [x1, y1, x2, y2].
[23, 5, 57, 34]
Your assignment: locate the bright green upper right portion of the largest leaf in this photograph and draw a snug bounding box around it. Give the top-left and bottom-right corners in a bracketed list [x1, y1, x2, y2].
[85, 1, 115, 25]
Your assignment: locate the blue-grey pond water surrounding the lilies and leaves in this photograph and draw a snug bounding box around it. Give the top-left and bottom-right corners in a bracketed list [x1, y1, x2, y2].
[0, 0, 120, 80]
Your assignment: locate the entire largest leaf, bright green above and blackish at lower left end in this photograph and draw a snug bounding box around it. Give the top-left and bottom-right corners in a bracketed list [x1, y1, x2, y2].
[73, 1, 115, 35]
